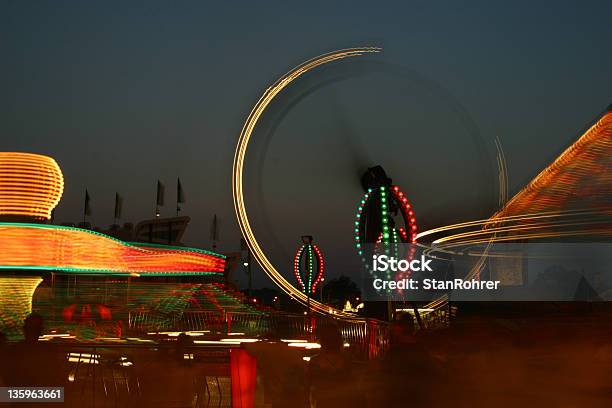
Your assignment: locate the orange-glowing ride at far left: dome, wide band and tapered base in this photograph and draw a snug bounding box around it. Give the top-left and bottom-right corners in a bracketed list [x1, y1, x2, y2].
[0, 152, 226, 337]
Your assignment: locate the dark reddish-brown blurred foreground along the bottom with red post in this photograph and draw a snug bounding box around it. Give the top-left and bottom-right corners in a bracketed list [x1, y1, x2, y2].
[0, 312, 612, 407]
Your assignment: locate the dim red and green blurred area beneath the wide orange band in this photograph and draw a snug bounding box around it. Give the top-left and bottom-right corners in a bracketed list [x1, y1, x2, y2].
[30, 279, 261, 341]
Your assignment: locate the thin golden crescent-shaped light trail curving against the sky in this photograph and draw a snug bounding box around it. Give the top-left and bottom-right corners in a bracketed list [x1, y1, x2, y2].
[232, 47, 382, 317]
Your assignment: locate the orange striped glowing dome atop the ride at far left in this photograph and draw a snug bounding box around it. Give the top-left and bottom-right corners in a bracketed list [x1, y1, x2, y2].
[0, 152, 64, 220]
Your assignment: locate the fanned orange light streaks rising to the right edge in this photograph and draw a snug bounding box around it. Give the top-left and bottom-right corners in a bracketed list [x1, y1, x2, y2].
[418, 110, 612, 250]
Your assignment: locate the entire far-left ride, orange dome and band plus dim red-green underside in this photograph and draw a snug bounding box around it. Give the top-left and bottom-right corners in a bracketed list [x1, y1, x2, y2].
[0, 152, 237, 337]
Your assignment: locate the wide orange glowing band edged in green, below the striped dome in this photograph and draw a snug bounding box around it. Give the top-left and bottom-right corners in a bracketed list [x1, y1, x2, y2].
[0, 223, 225, 275]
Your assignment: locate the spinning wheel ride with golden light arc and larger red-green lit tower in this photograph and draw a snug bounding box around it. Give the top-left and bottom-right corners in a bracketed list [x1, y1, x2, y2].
[232, 47, 500, 318]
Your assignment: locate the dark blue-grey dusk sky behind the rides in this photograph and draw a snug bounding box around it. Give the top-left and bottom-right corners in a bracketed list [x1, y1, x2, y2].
[0, 1, 612, 284]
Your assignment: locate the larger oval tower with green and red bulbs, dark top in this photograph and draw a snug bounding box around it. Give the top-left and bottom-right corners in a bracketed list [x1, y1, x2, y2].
[354, 166, 417, 316]
